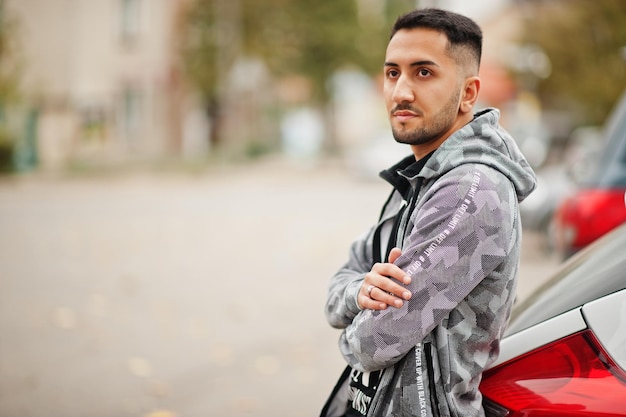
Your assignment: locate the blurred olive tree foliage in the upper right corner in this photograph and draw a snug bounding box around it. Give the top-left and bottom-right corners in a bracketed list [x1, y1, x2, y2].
[524, 0, 626, 124]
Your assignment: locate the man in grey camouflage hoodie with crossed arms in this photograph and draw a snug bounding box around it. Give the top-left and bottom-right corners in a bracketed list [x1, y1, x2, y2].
[322, 9, 536, 417]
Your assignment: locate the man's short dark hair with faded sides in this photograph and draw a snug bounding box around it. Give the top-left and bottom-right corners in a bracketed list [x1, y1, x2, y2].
[389, 8, 483, 70]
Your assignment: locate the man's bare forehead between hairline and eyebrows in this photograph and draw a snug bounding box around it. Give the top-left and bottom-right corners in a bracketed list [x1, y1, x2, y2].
[385, 28, 452, 65]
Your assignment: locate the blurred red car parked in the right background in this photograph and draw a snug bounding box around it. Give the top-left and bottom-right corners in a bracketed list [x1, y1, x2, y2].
[553, 93, 626, 257]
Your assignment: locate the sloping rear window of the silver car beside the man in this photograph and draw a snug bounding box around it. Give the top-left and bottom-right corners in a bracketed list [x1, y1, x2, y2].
[507, 225, 626, 334]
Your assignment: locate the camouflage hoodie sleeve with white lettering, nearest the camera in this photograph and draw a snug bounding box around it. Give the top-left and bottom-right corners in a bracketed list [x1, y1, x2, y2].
[340, 164, 519, 371]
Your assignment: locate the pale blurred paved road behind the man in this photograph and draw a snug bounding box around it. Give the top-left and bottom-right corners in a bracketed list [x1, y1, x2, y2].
[0, 158, 556, 417]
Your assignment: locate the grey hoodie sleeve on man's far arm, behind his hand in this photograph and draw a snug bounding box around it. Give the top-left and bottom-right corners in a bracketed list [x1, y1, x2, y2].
[326, 224, 374, 329]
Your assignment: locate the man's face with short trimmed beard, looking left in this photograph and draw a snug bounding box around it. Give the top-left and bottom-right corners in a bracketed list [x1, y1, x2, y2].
[384, 28, 465, 147]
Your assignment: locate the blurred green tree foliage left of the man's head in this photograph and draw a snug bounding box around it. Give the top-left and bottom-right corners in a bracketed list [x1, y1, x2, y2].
[182, 0, 415, 145]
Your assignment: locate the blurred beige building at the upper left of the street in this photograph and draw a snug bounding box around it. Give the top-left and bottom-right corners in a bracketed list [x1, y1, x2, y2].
[5, 0, 188, 169]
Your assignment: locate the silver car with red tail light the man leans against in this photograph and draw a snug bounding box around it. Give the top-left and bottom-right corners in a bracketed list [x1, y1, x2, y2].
[481, 207, 626, 417]
